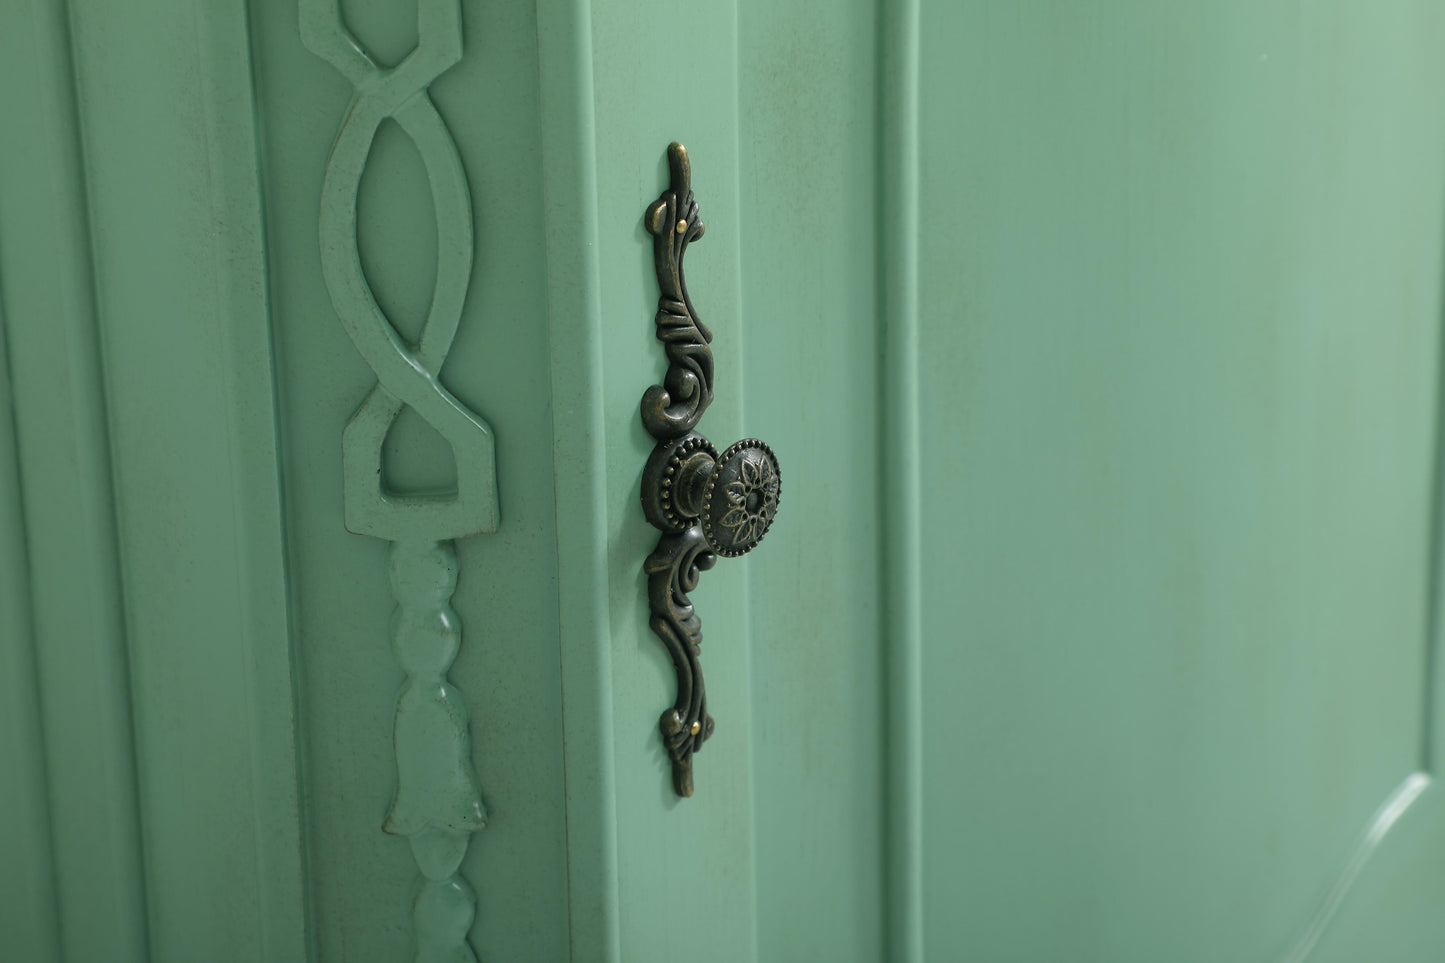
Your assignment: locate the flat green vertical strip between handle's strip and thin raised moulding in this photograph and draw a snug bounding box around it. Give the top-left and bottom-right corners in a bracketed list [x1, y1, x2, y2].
[739, 0, 884, 963]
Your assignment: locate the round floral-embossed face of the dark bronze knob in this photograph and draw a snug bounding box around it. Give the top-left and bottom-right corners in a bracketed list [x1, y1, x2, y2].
[701, 438, 782, 558]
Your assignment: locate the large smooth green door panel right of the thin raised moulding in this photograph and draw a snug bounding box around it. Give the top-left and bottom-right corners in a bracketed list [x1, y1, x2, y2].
[919, 3, 1445, 960]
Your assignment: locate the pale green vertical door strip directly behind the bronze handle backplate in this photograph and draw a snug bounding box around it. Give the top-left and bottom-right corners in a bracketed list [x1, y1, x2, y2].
[591, 0, 768, 962]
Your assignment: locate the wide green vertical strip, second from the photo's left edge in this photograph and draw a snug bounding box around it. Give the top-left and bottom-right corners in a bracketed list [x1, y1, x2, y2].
[0, 0, 149, 963]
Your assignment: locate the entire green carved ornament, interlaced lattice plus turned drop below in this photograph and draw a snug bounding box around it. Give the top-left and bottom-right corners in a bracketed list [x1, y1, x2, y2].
[301, 0, 497, 963]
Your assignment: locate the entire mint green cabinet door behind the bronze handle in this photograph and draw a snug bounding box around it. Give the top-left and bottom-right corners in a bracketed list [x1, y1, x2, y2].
[592, 1, 1445, 960]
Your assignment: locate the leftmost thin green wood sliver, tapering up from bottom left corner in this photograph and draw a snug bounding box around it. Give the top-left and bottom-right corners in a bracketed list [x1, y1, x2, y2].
[0, 294, 61, 963]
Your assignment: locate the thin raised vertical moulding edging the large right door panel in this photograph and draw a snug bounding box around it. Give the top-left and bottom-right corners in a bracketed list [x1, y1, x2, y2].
[879, 0, 923, 963]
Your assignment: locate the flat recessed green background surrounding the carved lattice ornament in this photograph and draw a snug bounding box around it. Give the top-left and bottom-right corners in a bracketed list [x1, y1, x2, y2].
[251, 0, 568, 963]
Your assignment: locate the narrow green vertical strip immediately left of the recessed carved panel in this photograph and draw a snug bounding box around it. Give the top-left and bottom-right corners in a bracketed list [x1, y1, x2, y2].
[198, 1, 315, 948]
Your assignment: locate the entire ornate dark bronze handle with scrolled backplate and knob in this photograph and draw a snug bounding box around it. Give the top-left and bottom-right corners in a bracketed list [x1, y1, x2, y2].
[642, 143, 782, 795]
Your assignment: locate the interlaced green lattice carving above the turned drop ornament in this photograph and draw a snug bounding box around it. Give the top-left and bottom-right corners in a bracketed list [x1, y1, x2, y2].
[301, 0, 497, 541]
